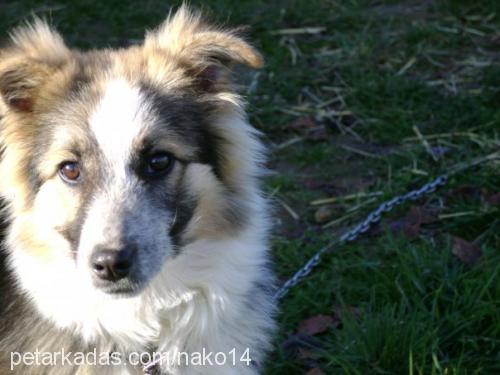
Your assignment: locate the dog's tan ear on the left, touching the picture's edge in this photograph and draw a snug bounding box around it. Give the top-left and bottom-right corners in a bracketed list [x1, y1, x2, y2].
[0, 19, 70, 112]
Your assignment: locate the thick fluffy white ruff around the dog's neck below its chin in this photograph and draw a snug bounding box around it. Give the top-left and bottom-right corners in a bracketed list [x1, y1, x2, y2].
[6, 219, 266, 352]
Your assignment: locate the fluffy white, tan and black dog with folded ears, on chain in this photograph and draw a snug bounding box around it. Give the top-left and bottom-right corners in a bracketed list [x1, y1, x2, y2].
[0, 5, 275, 375]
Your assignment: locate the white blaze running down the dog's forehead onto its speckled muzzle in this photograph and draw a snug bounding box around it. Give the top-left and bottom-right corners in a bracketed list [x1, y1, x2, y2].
[78, 78, 173, 284]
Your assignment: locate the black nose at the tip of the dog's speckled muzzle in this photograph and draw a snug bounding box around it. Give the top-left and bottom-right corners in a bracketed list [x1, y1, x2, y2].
[90, 247, 135, 281]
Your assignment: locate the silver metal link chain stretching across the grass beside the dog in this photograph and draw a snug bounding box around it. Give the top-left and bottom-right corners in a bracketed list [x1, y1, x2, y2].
[274, 175, 448, 300]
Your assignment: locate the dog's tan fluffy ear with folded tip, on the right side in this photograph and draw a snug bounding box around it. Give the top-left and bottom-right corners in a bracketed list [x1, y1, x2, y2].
[144, 5, 263, 89]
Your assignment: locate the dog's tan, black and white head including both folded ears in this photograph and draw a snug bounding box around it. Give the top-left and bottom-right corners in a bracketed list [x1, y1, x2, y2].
[0, 7, 261, 295]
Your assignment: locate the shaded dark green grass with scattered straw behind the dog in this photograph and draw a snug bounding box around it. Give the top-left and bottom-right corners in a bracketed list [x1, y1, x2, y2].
[0, 0, 500, 374]
